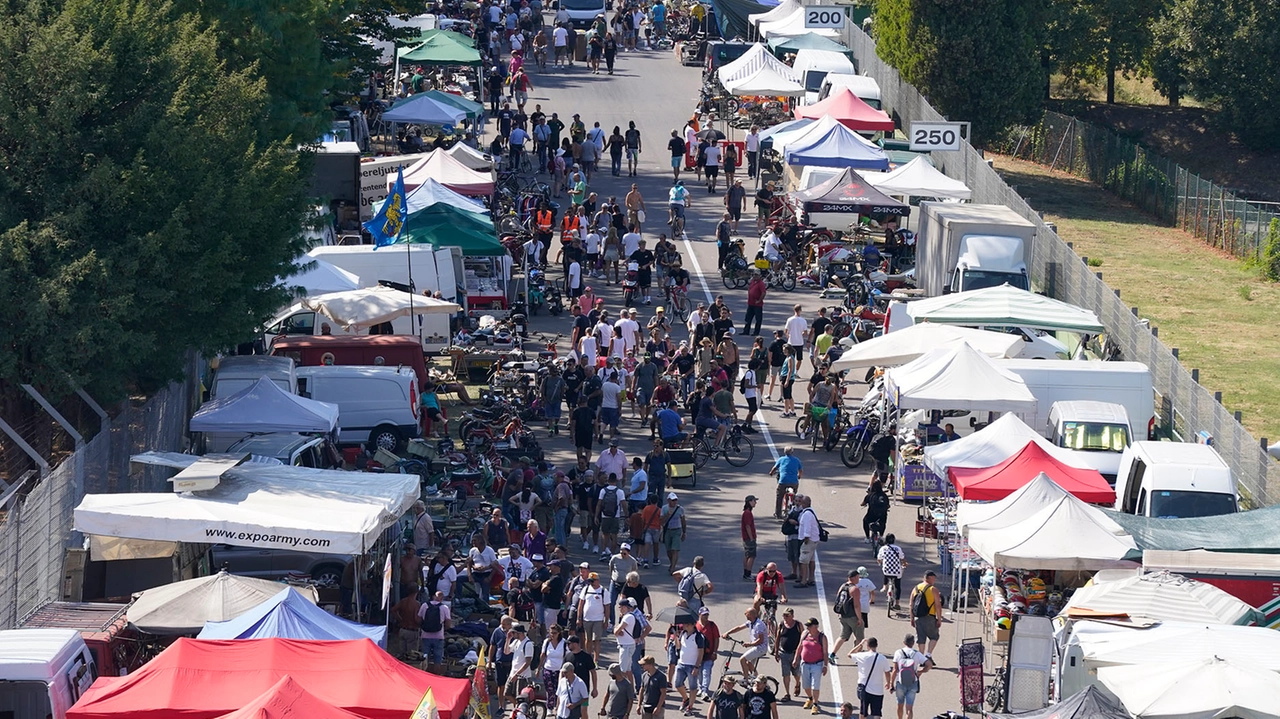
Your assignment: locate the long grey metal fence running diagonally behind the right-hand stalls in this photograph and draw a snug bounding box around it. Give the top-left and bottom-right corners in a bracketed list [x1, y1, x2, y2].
[842, 26, 1280, 507]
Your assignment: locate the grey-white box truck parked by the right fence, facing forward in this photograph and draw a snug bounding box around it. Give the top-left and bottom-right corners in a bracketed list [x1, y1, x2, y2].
[915, 202, 1036, 297]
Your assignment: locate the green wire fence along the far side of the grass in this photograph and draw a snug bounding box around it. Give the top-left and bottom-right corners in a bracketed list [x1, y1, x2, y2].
[992, 113, 1277, 260]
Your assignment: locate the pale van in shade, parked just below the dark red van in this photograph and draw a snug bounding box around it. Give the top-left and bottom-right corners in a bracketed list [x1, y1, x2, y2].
[298, 365, 420, 452]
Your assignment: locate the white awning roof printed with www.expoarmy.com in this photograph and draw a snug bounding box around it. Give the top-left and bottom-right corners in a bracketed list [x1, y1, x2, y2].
[74, 464, 419, 550]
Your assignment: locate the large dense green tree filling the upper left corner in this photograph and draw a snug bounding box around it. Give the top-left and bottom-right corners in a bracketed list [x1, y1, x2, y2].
[0, 0, 308, 442]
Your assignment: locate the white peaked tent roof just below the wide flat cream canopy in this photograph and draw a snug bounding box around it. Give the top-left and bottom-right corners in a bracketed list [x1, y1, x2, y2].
[884, 343, 1036, 411]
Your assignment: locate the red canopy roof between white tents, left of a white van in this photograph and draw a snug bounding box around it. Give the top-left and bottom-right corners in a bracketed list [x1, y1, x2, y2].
[947, 441, 1116, 504]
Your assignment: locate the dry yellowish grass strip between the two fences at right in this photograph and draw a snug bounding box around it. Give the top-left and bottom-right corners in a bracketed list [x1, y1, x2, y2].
[993, 155, 1280, 441]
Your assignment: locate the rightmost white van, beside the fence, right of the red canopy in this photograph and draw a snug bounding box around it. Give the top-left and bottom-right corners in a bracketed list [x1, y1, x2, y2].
[1115, 441, 1239, 518]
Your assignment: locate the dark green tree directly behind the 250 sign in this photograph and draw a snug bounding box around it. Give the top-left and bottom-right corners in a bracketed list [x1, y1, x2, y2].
[876, 0, 1044, 142]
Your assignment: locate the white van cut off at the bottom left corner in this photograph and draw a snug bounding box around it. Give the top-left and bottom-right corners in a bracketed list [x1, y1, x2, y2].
[0, 629, 97, 719]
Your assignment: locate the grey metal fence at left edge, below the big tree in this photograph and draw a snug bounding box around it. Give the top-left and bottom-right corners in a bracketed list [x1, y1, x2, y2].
[0, 356, 202, 629]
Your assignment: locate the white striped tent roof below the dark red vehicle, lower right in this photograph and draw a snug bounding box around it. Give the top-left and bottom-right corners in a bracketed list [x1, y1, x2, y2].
[1065, 572, 1265, 624]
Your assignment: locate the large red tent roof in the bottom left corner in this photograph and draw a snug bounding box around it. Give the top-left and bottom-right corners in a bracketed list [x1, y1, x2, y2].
[67, 638, 471, 719]
